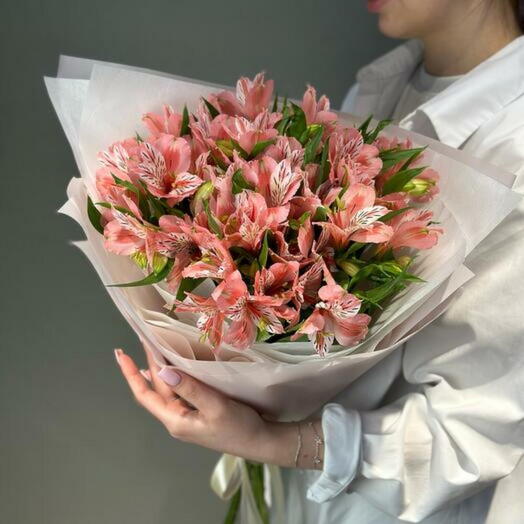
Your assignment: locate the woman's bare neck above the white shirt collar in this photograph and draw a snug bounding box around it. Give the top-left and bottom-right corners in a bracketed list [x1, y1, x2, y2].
[421, 7, 522, 76]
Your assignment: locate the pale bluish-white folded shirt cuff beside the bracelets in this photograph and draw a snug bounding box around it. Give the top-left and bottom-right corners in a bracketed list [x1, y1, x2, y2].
[307, 404, 362, 503]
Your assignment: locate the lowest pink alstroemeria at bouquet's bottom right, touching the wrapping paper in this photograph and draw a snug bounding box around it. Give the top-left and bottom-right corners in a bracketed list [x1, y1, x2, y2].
[292, 281, 371, 357]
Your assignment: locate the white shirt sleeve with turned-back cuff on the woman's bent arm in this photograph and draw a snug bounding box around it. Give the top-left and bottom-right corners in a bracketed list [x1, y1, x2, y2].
[308, 134, 524, 522]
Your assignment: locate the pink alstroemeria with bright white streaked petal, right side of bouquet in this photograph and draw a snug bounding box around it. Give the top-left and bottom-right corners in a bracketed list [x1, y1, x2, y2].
[317, 184, 393, 249]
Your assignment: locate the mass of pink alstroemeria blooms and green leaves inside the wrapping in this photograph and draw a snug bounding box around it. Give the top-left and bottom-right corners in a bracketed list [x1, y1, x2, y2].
[88, 74, 442, 356]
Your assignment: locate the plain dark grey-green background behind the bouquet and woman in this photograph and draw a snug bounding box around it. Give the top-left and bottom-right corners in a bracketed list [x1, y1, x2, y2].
[0, 0, 394, 524]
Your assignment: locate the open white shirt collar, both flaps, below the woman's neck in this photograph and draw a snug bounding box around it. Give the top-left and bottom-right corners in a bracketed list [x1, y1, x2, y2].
[357, 36, 524, 147]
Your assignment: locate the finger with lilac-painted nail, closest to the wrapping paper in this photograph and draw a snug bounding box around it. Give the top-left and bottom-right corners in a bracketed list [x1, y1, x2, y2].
[157, 366, 225, 414]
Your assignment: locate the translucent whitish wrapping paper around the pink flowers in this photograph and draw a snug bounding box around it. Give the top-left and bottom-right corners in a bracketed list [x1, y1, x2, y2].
[46, 57, 519, 420]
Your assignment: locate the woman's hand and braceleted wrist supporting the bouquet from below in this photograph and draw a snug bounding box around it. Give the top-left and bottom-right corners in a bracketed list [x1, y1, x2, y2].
[115, 348, 314, 467]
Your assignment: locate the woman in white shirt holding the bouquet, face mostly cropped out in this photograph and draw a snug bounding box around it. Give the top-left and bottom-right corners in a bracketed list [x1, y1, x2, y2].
[116, 0, 524, 524]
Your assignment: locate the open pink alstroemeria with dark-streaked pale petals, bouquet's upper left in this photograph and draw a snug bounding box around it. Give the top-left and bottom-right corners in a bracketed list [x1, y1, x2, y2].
[136, 139, 202, 206]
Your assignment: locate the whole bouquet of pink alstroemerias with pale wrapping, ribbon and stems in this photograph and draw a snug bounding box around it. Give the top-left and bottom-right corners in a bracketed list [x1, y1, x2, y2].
[46, 57, 518, 518]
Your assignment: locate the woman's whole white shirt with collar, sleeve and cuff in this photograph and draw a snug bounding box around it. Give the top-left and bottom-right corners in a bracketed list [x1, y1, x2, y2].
[284, 37, 524, 524]
